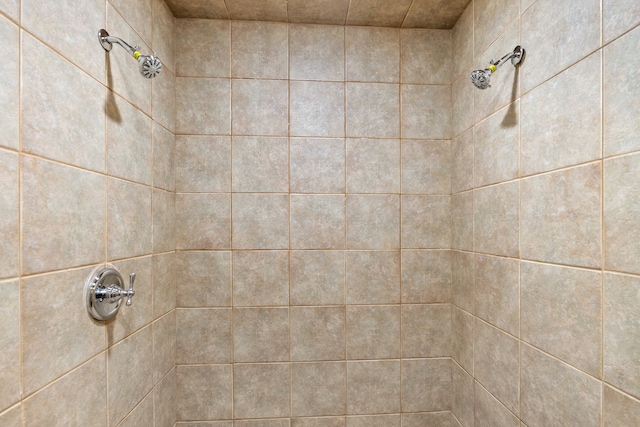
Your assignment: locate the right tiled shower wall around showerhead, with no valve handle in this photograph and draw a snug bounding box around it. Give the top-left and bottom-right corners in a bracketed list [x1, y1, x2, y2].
[451, 0, 640, 427]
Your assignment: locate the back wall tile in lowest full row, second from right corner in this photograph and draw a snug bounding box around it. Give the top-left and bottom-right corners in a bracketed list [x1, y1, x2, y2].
[347, 360, 401, 414]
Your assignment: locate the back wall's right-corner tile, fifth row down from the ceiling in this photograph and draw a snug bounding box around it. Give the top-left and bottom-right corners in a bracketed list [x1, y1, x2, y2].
[402, 250, 451, 303]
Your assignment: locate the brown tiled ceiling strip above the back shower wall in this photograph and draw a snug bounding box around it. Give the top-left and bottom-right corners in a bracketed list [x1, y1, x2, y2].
[165, 0, 471, 29]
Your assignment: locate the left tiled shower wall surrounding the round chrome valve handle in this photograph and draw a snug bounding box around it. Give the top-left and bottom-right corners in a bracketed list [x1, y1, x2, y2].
[0, 0, 176, 427]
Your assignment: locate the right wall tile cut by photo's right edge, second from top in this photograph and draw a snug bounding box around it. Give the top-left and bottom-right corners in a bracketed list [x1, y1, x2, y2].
[604, 25, 640, 155]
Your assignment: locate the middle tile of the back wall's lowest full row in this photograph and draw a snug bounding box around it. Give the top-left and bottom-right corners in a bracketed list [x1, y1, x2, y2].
[291, 362, 347, 416]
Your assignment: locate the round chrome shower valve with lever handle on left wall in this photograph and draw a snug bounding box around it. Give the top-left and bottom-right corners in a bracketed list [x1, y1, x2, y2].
[84, 265, 136, 320]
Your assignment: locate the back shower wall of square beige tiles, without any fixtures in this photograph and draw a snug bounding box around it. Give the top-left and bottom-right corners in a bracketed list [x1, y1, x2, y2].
[176, 20, 452, 427]
